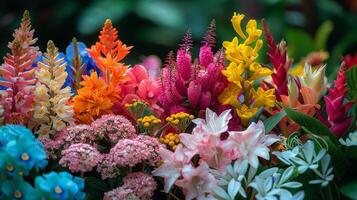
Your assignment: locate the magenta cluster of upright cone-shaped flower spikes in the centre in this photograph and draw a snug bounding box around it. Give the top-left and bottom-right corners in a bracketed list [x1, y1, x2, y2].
[159, 23, 226, 114]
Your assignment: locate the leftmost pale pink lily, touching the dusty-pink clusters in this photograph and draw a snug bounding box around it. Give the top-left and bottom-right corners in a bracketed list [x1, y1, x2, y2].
[152, 144, 190, 192]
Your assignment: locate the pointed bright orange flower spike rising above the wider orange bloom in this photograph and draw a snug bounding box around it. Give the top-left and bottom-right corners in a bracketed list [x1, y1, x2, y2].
[88, 19, 132, 83]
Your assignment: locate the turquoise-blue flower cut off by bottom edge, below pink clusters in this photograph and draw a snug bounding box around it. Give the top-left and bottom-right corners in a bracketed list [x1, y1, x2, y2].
[35, 172, 85, 200]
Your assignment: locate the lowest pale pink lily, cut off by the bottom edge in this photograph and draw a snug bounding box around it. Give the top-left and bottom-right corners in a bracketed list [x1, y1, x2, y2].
[176, 162, 216, 200]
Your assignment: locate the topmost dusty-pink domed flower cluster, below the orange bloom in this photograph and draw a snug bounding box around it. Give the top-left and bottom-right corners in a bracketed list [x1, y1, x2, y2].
[91, 115, 136, 144]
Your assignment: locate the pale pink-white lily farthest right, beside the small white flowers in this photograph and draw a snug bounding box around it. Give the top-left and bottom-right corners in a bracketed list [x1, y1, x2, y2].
[227, 121, 279, 168]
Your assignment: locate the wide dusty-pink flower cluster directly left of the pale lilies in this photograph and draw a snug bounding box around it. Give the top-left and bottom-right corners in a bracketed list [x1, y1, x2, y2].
[98, 135, 161, 179]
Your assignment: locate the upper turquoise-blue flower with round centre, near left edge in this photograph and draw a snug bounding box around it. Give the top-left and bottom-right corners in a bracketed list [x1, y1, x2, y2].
[6, 136, 46, 170]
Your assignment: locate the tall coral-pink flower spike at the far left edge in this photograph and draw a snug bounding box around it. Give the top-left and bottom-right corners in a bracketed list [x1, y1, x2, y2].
[0, 11, 40, 125]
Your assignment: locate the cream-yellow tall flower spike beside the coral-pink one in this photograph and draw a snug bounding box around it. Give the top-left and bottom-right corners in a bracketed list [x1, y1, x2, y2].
[33, 40, 73, 135]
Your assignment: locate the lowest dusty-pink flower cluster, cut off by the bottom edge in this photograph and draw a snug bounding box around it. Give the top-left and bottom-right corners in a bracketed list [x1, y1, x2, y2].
[122, 172, 157, 200]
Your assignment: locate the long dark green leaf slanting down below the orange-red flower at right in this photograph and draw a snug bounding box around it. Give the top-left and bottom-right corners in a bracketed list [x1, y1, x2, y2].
[283, 106, 339, 145]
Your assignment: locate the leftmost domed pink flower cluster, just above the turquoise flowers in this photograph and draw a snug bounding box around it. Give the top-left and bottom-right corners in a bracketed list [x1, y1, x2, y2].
[59, 143, 102, 172]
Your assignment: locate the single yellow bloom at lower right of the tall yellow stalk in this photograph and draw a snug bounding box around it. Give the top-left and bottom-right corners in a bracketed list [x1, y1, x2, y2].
[251, 87, 275, 108]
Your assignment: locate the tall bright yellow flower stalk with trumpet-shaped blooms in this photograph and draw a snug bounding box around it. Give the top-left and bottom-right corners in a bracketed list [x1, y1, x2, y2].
[219, 13, 275, 126]
